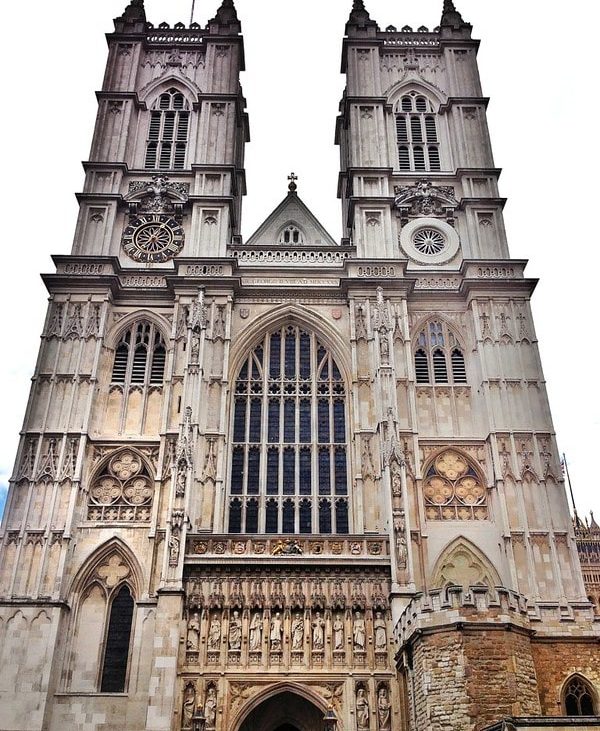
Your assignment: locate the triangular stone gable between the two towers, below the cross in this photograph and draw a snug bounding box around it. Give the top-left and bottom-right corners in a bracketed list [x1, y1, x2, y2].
[246, 191, 339, 248]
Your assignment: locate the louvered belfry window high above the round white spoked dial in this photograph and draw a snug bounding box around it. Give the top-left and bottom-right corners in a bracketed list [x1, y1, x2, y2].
[396, 92, 441, 172]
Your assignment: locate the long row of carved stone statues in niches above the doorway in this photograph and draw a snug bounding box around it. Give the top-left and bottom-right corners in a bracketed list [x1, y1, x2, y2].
[186, 610, 387, 653]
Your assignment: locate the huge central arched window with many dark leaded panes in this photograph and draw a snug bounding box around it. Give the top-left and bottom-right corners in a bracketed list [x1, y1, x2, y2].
[228, 325, 349, 534]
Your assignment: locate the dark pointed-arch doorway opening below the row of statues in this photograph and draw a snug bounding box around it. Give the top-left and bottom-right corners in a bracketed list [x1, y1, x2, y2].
[239, 691, 324, 731]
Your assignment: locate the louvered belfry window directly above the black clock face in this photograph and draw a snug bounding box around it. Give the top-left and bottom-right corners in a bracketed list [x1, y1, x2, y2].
[144, 89, 190, 170]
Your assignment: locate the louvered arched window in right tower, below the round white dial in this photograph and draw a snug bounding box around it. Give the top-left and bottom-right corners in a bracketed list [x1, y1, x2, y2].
[415, 320, 467, 384]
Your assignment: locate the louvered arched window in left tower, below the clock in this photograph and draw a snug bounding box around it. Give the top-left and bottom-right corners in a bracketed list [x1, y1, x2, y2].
[112, 321, 167, 387]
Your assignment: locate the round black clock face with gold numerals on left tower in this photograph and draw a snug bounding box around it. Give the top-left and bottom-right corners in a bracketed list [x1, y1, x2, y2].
[122, 214, 184, 262]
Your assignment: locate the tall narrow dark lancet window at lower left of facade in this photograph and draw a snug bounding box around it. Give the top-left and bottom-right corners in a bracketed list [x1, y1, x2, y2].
[100, 586, 133, 693]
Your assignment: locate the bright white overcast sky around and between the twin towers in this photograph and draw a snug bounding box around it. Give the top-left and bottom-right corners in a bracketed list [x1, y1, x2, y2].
[0, 0, 600, 514]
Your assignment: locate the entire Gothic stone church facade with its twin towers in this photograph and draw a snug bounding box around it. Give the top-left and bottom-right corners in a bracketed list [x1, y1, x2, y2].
[0, 0, 600, 731]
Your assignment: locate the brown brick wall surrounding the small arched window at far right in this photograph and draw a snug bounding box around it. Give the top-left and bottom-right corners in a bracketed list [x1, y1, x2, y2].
[532, 639, 600, 716]
